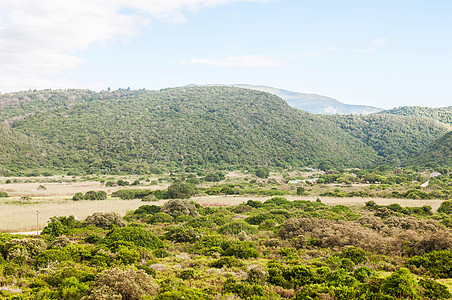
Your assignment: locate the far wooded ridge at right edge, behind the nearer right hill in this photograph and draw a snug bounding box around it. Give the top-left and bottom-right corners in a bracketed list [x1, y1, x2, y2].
[381, 106, 452, 125]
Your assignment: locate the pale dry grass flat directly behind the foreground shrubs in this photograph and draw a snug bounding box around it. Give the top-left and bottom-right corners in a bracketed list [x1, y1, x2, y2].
[0, 196, 443, 232]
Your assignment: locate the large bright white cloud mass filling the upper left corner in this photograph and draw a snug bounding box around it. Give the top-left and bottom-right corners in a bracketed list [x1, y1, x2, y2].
[0, 0, 264, 92]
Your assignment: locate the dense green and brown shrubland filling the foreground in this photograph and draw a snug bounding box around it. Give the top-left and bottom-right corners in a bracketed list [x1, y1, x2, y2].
[0, 190, 452, 300]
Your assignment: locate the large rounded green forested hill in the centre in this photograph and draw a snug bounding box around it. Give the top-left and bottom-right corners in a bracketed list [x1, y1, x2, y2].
[8, 87, 377, 173]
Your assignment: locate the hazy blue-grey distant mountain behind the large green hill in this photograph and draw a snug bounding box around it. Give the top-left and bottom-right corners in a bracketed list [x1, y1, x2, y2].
[234, 84, 383, 115]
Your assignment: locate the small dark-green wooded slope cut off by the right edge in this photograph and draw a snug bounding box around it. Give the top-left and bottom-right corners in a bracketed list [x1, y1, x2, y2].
[408, 131, 452, 168]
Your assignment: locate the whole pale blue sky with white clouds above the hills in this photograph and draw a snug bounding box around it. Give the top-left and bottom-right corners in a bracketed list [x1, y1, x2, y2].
[0, 0, 452, 108]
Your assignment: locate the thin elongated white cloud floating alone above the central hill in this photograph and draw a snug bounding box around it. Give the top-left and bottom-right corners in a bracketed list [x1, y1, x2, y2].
[181, 55, 284, 67]
